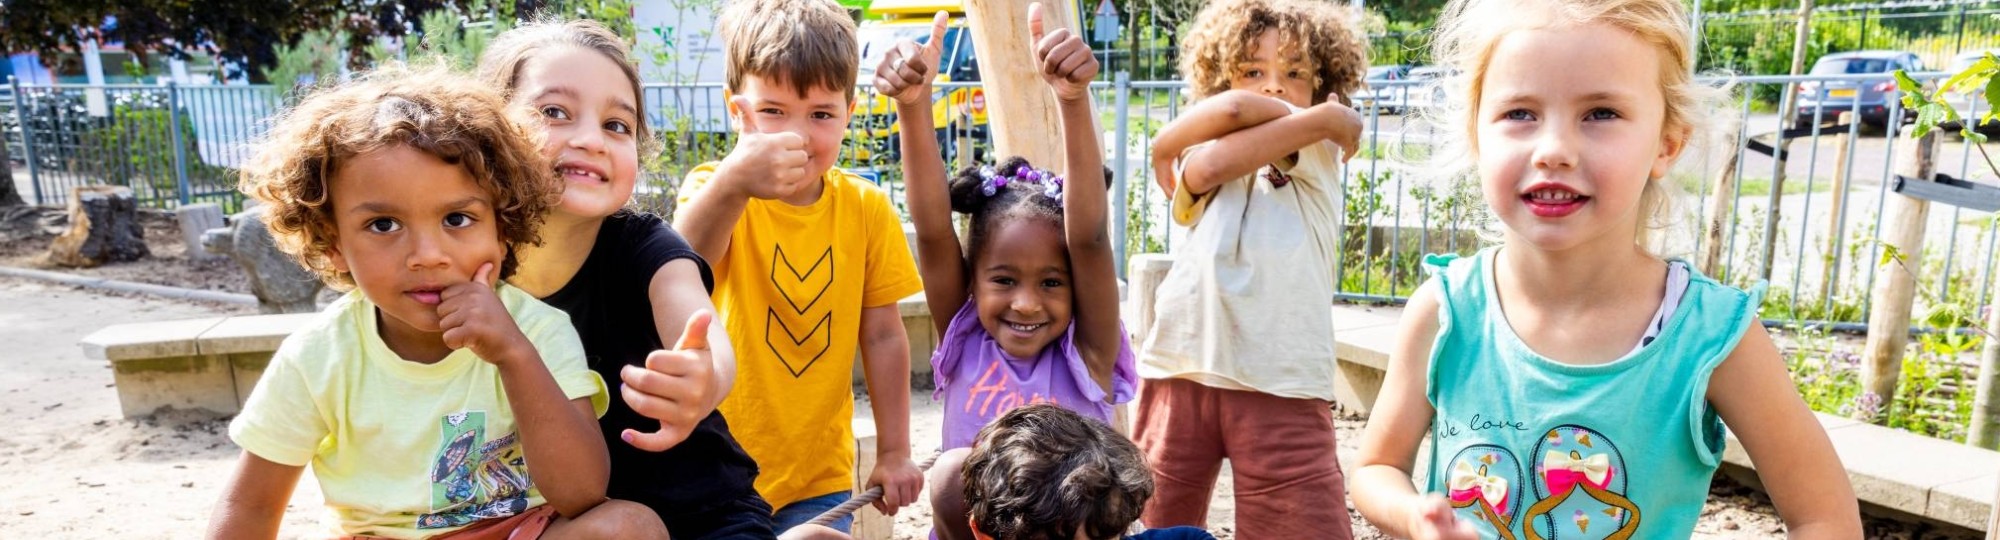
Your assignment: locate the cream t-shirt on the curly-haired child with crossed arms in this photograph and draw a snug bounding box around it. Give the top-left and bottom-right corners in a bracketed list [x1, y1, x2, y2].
[1138, 133, 1342, 400]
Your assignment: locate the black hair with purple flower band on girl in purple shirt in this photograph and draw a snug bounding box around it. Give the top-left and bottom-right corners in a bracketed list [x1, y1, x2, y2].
[948, 156, 1112, 262]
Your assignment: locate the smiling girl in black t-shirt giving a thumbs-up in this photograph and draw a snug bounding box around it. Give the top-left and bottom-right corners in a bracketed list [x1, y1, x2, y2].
[480, 20, 824, 538]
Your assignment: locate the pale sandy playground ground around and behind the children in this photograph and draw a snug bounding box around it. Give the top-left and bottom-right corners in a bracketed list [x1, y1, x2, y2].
[0, 204, 1978, 540]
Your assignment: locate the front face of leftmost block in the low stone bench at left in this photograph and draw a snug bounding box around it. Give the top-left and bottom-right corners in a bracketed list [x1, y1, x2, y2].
[112, 354, 242, 418]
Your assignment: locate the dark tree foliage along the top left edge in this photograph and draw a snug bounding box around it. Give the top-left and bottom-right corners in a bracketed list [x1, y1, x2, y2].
[0, 0, 468, 83]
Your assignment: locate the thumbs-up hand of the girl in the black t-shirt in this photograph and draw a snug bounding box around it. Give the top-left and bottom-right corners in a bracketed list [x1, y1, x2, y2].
[618, 310, 720, 452]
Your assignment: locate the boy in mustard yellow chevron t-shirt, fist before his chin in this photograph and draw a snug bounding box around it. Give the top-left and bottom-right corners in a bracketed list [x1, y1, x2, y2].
[674, 0, 924, 534]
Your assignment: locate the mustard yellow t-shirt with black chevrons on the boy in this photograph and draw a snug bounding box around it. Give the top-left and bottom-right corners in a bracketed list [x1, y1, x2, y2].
[680, 164, 924, 508]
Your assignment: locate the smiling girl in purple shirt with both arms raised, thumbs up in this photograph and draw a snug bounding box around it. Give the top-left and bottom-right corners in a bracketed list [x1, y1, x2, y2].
[876, 4, 1136, 540]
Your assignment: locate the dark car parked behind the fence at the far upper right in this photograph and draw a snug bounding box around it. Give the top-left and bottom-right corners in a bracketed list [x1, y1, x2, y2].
[1792, 50, 1926, 128]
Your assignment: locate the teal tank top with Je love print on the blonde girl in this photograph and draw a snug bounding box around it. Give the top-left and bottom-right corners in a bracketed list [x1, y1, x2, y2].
[1424, 248, 1762, 540]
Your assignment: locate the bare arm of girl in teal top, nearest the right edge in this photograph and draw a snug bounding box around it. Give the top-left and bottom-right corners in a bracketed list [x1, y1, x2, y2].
[1708, 320, 1862, 538]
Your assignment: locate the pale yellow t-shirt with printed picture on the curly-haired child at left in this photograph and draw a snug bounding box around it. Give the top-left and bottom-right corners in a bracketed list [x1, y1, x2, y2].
[230, 284, 610, 538]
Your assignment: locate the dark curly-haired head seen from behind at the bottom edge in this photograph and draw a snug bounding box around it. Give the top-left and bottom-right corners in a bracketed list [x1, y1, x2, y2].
[964, 404, 1152, 540]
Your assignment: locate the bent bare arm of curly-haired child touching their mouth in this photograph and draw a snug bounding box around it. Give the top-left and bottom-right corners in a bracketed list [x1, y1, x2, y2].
[438, 264, 612, 518]
